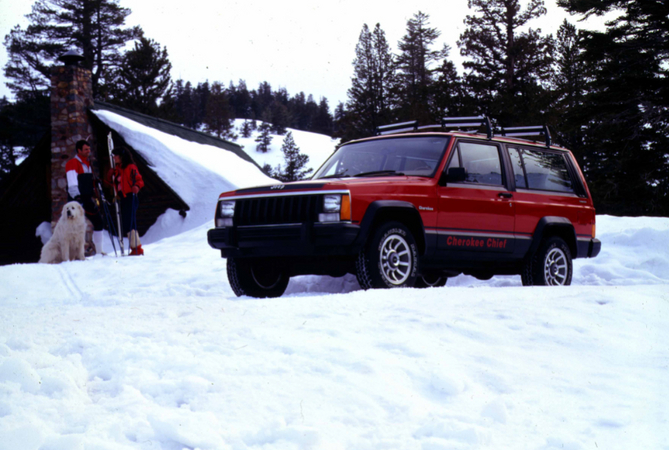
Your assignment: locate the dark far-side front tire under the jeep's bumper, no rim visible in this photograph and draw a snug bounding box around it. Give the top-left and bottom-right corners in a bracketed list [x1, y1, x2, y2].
[228, 258, 290, 298]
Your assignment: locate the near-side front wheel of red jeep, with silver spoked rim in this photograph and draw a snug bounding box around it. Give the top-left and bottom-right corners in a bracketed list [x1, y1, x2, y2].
[355, 222, 418, 289]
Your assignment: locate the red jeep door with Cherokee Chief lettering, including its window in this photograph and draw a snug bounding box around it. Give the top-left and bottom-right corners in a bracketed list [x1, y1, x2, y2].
[437, 139, 515, 255]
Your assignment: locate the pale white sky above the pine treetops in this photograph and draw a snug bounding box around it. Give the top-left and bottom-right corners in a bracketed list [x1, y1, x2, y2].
[0, 0, 602, 109]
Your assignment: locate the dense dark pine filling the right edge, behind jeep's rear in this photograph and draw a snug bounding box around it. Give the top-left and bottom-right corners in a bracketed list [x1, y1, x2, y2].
[558, 0, 669, 215]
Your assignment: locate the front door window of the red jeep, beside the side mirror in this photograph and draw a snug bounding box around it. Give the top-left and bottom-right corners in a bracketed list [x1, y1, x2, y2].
[448, 142, 502, 185]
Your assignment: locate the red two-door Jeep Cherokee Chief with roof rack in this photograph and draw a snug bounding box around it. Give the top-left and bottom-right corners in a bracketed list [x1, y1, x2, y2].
[208, 116, 601, 298]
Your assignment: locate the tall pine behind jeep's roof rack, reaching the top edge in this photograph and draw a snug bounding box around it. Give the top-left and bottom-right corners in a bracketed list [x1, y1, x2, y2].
[458, 0, 553, 126]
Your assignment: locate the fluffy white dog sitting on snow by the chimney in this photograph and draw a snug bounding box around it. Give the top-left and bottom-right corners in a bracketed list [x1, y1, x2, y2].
[39, 202, 86, 264]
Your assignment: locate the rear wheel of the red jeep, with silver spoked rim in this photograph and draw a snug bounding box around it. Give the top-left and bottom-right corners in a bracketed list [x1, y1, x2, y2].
[520, 237, 573, 286]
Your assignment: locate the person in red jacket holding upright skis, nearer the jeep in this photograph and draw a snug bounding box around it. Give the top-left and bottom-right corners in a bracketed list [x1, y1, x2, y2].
[108, 147, 144, 255]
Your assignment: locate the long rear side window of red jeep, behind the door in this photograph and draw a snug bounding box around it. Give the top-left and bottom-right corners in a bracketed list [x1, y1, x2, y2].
[510, 149, 574, 193]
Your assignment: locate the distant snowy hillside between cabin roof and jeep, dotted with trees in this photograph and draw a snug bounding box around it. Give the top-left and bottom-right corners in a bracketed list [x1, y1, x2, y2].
[235, 119, 339, 173]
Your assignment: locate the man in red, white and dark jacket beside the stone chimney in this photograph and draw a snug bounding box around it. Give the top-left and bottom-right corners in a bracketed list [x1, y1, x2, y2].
[65, 140, 104, 255]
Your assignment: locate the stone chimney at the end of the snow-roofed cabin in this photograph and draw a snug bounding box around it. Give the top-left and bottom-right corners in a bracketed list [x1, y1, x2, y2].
[51, 50, 96, 224]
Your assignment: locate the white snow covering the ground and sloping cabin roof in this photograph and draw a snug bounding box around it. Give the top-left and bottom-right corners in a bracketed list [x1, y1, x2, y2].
[5, 112, 669, 450]
